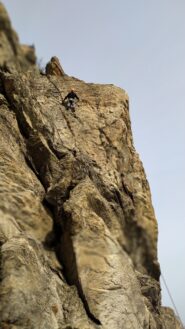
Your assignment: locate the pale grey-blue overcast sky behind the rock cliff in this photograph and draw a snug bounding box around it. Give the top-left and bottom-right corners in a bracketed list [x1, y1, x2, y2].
[3, 0, 185, 322]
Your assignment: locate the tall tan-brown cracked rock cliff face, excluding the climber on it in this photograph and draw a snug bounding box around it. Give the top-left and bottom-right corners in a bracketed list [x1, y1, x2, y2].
[0, 4, 181, 329]
